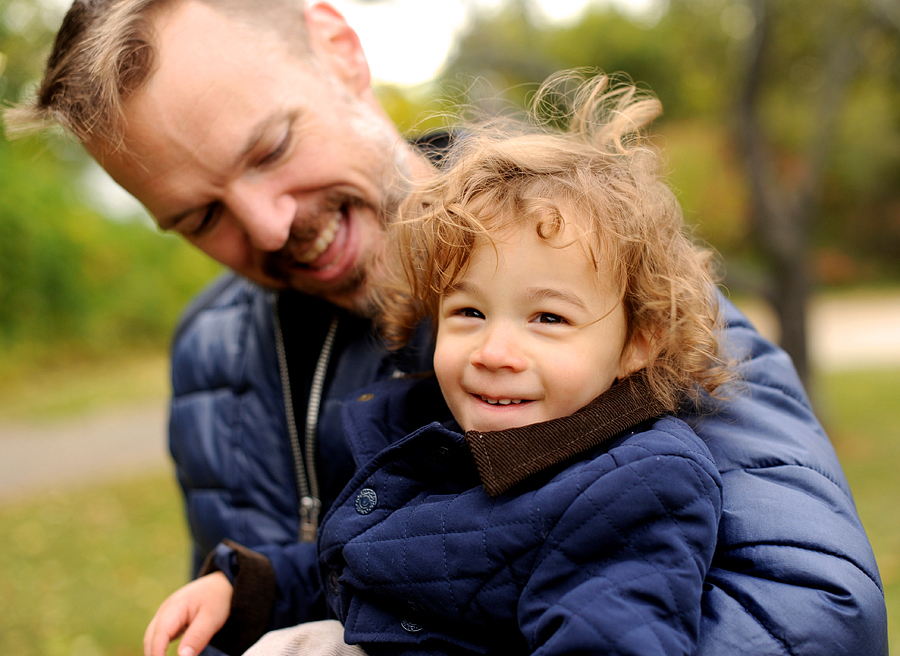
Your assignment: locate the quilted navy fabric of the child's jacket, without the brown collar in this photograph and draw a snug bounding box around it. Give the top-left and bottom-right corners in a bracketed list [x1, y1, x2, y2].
[320, 410, 721, 649]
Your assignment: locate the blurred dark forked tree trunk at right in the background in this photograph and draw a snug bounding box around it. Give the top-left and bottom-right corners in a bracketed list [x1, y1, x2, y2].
[736, 0, 861, 384]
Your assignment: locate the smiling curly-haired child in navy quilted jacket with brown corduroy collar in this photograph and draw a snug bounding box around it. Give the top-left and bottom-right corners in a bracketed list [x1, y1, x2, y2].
[147, 78, 731, 656]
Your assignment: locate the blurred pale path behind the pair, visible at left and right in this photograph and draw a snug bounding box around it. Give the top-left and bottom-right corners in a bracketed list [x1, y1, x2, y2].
[0, 294, 900, 503]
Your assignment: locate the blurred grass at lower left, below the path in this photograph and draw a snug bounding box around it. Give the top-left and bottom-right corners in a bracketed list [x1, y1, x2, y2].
[0, 474, 188, 656]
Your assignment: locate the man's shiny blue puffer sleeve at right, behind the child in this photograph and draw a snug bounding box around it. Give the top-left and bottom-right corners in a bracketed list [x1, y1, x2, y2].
[692, 294, 887, 656]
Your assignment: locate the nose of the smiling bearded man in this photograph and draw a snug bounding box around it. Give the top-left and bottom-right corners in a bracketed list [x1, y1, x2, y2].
[226, 184, 297, 252]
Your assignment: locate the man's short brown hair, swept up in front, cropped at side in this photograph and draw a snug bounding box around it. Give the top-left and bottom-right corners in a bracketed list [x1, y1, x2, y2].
[5, 0, 309, 148]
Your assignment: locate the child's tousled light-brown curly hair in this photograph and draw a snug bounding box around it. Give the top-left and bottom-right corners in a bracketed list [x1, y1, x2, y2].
[376, 73, 733, 410]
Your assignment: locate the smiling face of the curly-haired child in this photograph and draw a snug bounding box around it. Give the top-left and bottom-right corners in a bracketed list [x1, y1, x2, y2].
[434, 227, 646, 431]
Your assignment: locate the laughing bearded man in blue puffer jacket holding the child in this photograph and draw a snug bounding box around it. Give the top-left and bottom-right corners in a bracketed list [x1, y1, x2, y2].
[10, 0, 887, 655]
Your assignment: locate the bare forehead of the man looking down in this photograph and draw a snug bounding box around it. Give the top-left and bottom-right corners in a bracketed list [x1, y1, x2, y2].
[96, 2, 311, 213]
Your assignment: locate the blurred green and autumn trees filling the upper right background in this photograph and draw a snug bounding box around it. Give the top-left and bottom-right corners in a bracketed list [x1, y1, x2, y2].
[436, 0, 900, 379]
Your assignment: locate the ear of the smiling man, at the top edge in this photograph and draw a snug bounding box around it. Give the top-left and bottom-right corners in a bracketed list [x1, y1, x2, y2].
[305, 2, 372, 96]
